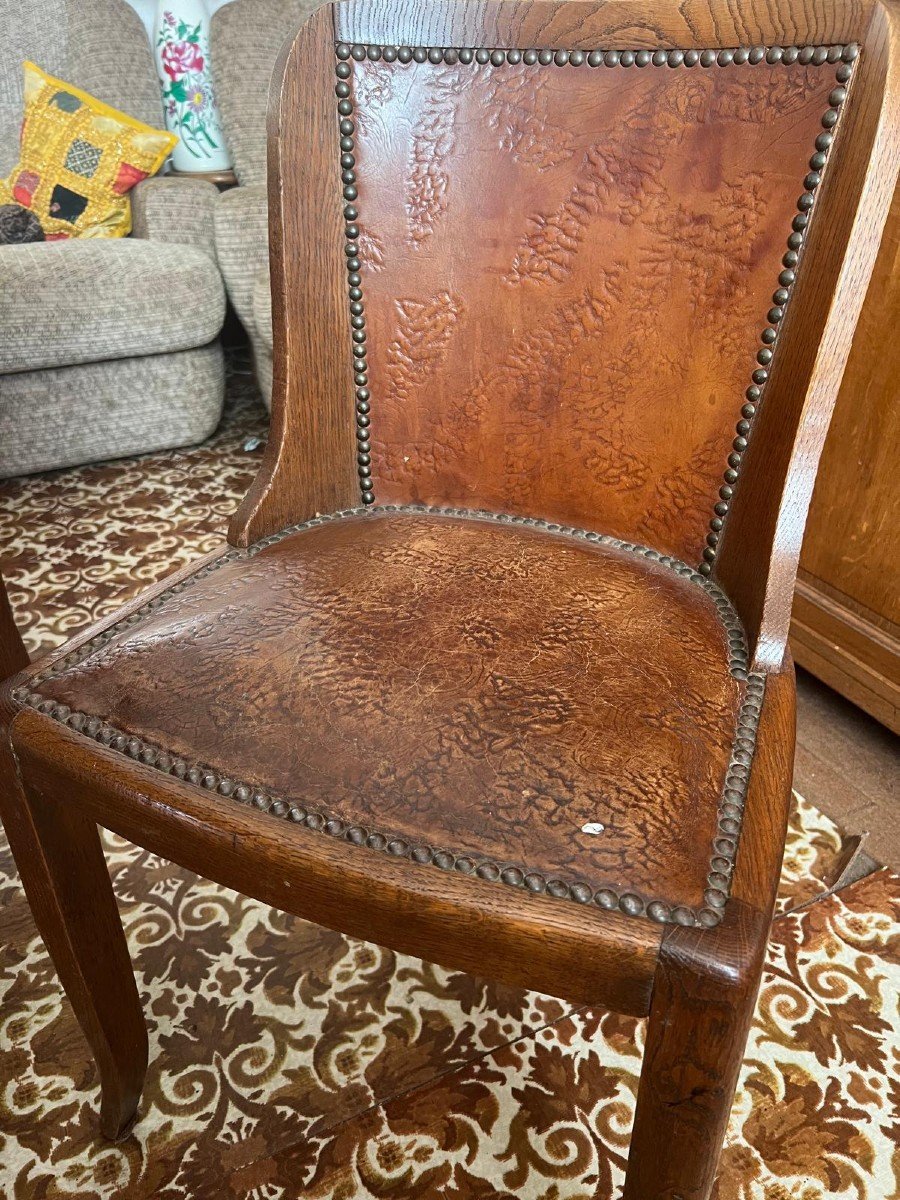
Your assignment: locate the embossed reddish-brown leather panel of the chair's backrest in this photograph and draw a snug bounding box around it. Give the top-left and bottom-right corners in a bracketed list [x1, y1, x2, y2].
[352, 61, 835, 563]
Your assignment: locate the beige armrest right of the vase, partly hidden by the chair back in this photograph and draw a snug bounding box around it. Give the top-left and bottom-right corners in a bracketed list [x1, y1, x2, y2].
[215, 184, 269, 332]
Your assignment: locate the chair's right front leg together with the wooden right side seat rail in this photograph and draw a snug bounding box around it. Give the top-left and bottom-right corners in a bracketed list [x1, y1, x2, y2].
[623, 659, 796, 1200]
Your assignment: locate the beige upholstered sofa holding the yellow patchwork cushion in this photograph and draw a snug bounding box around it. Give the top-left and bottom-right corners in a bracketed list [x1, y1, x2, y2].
[0, 0, 224, 478]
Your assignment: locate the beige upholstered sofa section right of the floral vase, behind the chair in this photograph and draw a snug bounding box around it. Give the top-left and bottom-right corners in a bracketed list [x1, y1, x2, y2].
[211, 0, 320, 403]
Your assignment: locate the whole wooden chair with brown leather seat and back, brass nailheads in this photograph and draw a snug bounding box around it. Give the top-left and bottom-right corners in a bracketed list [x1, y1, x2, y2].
[2, 0, 899, 1200]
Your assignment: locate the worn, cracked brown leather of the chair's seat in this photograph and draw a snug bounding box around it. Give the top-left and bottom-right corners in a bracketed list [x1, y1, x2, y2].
[40, 514, 742, 906]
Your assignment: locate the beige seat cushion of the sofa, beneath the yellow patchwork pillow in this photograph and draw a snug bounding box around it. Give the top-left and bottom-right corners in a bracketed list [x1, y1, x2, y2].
[0, 239, 224, 372]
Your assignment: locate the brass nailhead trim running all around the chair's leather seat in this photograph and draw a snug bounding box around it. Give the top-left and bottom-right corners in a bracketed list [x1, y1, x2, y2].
[13, 504, 766, 928]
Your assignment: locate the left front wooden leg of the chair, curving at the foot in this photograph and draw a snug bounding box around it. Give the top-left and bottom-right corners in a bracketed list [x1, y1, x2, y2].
[0, 731, 148, 1140]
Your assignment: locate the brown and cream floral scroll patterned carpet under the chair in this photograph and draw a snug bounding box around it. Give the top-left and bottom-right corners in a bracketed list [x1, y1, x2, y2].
[0, 374, 900, 1200]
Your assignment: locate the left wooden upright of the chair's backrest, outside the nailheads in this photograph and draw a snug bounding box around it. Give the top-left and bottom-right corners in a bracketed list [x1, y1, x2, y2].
[229, 6, 358, 546]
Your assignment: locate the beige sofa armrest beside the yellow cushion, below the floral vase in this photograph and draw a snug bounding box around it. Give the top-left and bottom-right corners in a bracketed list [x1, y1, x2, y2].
[131, 175, 218, 262]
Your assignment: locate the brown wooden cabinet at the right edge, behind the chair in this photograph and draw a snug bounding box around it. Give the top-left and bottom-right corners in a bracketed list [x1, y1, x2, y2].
[791, 177, 900, 732]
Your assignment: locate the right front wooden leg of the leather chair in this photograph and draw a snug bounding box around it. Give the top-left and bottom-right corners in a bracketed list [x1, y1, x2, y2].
[623, 900, 768, 1200]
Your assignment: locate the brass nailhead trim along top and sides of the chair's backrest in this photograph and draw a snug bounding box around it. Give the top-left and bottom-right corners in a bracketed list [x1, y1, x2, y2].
[335, 42, 859, 556]
